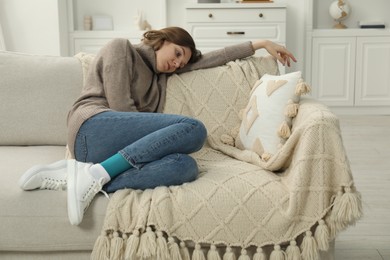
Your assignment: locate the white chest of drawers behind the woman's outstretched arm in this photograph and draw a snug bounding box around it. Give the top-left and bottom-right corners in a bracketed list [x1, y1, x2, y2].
[186, 3, 286, 73]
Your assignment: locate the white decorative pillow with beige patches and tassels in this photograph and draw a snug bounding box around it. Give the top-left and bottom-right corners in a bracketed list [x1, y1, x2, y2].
[235, 71, 310, 161]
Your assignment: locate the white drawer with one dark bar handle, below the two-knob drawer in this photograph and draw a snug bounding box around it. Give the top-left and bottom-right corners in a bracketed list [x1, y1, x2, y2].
[190, 23, 286, 42]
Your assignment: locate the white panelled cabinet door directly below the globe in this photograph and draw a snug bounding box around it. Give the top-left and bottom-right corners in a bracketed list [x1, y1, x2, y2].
[312, 37, 356, 106]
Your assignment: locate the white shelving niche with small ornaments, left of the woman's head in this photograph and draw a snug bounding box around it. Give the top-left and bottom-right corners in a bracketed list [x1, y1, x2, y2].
[67, 0, 166, 55]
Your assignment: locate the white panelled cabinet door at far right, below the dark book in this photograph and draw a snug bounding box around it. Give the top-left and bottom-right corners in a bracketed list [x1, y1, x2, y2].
[356, 36, 390, 106]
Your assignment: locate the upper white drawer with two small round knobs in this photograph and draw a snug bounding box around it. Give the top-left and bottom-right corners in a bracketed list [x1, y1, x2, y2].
[187, 8, 286, 23]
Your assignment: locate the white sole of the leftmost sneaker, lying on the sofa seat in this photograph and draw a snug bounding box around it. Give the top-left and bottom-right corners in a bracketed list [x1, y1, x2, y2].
[18, 160, 67, 190]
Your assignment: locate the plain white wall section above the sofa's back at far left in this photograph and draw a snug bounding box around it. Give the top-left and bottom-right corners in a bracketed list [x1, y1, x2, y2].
[0, 0, 67, 55]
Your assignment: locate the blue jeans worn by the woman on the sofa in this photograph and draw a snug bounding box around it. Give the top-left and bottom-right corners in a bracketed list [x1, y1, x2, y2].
[75, 111, 207, 192]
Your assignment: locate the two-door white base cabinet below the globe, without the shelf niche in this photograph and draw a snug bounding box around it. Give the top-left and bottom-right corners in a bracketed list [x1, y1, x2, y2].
[311, 31, 390, 108]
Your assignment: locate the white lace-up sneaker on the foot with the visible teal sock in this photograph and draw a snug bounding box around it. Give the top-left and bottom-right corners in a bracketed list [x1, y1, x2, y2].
[68, 161, 108, 225]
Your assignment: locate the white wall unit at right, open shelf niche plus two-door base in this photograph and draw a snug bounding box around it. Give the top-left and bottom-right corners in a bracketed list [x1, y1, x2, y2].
[305, 0, 390, 114]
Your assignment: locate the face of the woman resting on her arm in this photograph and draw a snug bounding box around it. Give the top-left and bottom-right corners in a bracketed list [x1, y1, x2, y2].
[156, 41, 191, 73]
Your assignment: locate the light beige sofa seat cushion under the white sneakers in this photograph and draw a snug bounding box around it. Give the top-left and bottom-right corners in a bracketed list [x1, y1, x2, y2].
[0, 146, 108, 251]
